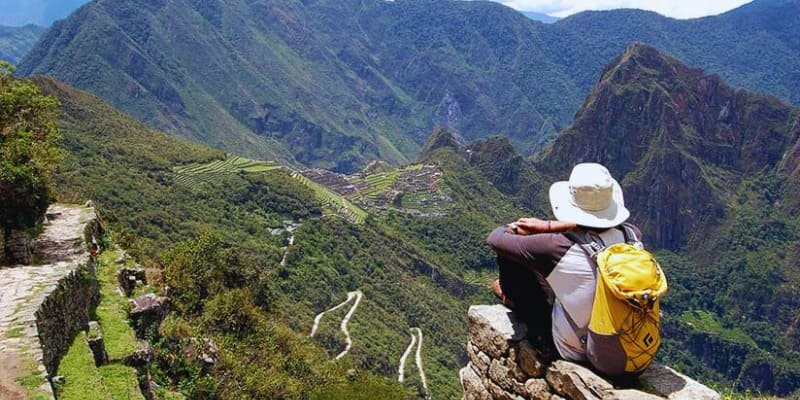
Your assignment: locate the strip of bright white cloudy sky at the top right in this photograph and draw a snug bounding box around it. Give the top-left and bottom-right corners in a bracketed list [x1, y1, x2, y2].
[494, 0, 750, 18]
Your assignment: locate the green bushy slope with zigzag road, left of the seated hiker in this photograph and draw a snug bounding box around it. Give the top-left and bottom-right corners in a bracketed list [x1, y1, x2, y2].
[35, 77, 521, 399]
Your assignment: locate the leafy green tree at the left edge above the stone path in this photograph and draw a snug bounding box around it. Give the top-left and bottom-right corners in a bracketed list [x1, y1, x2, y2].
[0, 61, 61, 264]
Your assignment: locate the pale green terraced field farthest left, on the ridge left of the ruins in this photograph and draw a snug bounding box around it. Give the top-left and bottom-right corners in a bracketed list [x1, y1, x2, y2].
[173, 155, 282, 186]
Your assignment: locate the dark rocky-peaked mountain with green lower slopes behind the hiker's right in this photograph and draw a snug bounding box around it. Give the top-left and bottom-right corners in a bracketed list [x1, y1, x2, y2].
[465, 44, 800, 395]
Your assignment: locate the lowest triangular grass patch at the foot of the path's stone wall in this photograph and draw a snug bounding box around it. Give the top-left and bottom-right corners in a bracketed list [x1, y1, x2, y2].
[57, 332, 112, 400]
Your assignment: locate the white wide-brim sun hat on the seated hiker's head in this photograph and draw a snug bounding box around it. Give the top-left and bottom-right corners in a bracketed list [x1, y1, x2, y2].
[550, 163, 631, 229]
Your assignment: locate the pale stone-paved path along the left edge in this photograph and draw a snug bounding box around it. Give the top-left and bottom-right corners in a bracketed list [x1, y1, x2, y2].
[0, 204, 95, 400]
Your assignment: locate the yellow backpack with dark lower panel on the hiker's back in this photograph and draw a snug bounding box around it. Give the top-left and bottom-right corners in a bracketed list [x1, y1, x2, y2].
[565, 224, 667, 376]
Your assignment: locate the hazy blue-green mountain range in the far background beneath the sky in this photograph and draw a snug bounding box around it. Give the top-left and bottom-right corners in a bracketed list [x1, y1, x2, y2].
[19, 0, 800, 172]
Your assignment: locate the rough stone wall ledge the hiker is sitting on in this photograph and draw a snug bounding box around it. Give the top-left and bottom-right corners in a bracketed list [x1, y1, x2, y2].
[460, 305, 720, 400]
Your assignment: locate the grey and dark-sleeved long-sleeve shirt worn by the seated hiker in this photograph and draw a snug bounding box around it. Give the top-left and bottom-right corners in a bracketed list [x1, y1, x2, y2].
[487, 227, 641, 361]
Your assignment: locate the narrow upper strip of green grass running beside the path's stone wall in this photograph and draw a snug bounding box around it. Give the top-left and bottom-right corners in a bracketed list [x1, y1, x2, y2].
[95, 250, 137, 361]
